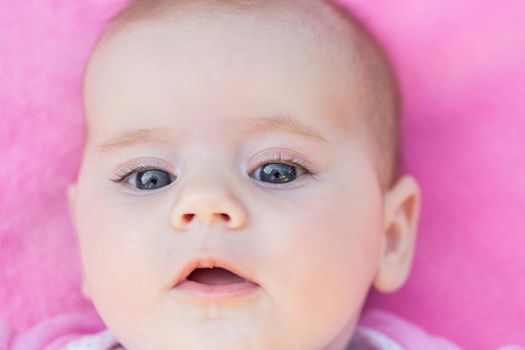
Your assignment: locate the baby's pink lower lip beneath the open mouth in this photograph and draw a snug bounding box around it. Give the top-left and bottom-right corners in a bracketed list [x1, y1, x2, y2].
[175, 280, 259, 298]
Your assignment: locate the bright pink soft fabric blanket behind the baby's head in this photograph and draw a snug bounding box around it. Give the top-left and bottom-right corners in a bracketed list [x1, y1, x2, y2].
[0, 0, 525, 350]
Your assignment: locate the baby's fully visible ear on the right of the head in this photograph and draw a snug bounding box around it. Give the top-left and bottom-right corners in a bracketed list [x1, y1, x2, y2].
[374, 176, 421, 292]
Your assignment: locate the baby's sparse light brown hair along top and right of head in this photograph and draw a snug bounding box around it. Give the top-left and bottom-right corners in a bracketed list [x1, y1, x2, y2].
[94, 0, 401, 190]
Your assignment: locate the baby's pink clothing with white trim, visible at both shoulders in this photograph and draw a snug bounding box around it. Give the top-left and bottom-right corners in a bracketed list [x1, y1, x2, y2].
[0, 309, 461, 350]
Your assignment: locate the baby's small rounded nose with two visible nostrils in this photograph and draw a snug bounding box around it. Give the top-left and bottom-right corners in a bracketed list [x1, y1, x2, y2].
[171, 182, 247, 231]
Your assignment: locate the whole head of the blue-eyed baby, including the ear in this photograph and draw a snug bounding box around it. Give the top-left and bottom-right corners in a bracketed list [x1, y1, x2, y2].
[69, 0, 420, 350]
